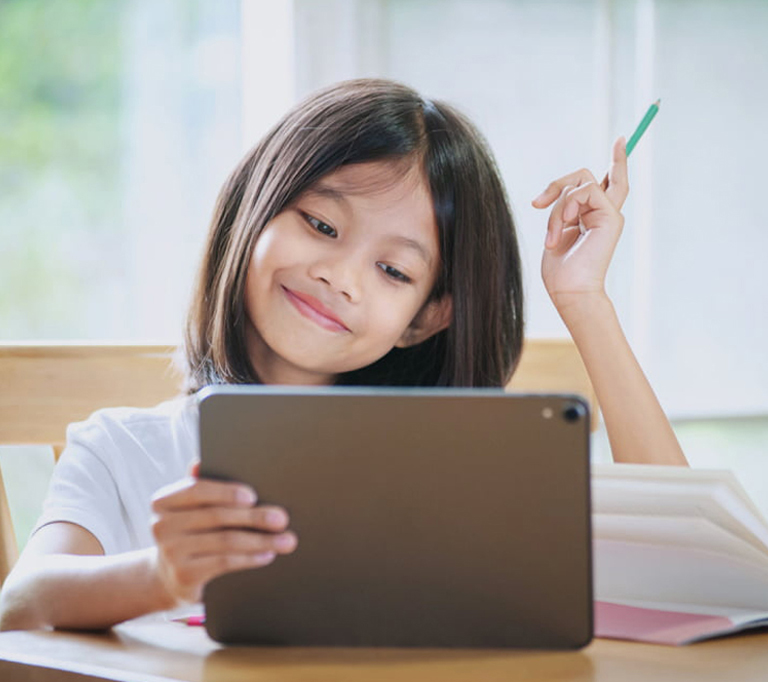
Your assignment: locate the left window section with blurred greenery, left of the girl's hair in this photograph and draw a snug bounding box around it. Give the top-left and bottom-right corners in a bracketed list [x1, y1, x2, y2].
[0, 0, 241, 340]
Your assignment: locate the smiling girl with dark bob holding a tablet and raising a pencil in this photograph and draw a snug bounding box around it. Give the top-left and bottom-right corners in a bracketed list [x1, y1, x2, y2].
[0, 80, 685, 628]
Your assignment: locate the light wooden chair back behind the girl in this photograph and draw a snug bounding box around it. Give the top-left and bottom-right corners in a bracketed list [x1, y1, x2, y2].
[0, 340, 595, 584]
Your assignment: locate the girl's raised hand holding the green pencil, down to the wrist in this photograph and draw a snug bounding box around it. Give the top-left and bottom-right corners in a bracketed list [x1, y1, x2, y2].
[532, 137, 629, 310]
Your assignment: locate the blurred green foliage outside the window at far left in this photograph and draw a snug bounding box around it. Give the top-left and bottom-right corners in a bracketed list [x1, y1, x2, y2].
[0, 0, 125, 339]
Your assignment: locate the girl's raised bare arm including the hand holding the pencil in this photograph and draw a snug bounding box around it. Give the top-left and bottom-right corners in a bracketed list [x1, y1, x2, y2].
[533, 138, 688, 466]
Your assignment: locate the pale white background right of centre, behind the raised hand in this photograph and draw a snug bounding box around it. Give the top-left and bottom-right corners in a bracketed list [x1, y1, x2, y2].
[282, 0, 768, 416]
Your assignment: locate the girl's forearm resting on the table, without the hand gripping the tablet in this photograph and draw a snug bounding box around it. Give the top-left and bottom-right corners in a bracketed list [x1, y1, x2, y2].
[0, 548, 176, 630]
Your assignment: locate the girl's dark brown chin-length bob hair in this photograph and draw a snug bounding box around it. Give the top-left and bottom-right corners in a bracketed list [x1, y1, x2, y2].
[183, 79, 523, 393]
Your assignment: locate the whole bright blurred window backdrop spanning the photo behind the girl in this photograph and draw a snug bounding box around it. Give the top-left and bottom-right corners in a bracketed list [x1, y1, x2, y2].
[0, 0, 768, 494]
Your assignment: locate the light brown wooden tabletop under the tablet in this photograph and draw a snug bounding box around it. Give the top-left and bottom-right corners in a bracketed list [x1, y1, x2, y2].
[0, 620, 768, 682]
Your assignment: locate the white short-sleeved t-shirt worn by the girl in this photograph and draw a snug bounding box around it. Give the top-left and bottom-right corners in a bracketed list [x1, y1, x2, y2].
[35, 396, 200, 554]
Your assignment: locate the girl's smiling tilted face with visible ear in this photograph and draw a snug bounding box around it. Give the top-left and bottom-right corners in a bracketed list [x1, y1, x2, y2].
[245, 162, 451, 384]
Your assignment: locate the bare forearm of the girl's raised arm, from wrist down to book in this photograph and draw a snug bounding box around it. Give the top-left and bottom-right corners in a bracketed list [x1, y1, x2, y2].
[555, 294, 688, 466]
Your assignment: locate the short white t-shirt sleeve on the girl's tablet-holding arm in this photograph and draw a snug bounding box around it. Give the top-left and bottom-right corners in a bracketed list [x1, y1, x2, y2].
[33, 419, 130, 554]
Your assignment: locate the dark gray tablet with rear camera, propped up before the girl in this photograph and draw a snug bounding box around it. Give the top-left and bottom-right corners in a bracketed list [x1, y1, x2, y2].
[200, 387, 592, 648]
